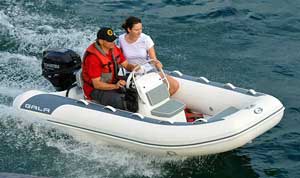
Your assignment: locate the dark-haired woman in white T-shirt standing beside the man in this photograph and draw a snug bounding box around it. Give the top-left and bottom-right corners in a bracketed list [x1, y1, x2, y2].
[119, 16, 179, 95]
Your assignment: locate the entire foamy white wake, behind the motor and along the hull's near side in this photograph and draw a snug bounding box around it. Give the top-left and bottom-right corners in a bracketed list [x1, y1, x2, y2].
[0, 3, 192, 177]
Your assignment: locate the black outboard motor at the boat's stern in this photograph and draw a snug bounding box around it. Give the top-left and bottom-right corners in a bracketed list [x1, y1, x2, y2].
[42, 49, 81, 91]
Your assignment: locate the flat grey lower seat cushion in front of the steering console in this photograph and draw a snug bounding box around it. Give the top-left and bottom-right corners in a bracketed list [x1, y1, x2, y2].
[151, 99, 185, 117]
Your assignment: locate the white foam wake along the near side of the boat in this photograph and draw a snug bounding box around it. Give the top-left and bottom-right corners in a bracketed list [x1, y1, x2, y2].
[0, 105, 185, 177]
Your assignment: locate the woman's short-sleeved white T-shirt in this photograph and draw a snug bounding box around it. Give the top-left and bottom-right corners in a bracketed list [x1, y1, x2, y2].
[119, 33, 154, 64]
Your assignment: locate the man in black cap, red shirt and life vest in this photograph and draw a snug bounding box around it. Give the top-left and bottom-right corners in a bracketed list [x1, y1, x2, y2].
[82, 27, 135, 109]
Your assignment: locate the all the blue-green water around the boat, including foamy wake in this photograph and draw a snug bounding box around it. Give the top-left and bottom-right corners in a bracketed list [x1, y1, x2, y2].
[0, 0, 300, 178]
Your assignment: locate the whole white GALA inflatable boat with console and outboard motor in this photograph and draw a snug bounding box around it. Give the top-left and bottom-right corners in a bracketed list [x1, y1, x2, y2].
[13, 50, 284, 156]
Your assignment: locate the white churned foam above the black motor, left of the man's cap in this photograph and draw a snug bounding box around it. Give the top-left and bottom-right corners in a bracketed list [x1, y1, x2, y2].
[0, 6, 95, 56]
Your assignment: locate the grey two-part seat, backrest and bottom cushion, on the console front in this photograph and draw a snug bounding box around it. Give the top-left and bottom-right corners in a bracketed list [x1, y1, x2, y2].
[146, 83, 185, 118]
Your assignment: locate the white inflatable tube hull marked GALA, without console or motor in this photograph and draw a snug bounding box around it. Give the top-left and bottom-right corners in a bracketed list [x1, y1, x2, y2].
[13, 72, 284, 156]
